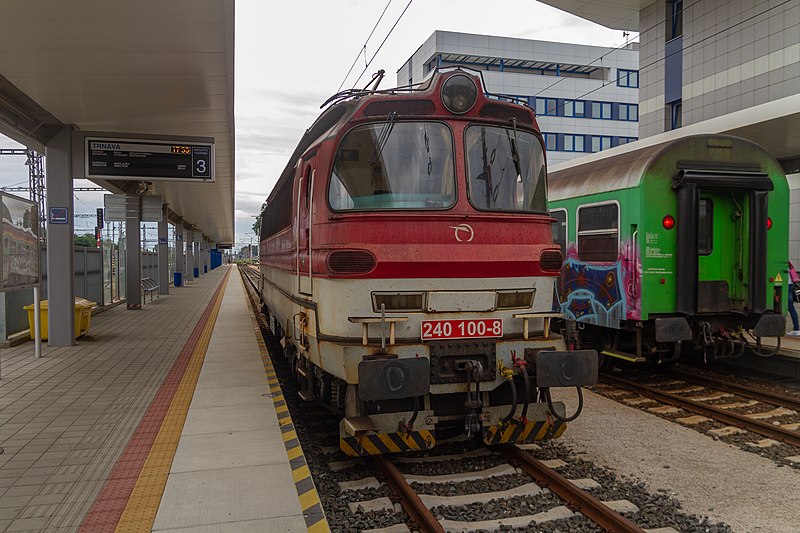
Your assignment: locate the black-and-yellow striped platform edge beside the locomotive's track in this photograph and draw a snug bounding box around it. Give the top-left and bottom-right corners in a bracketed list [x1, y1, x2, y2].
[245, 278, 330, 533]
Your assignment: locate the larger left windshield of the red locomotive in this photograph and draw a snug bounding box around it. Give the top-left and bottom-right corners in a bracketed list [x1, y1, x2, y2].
[328, 121, 456, 211]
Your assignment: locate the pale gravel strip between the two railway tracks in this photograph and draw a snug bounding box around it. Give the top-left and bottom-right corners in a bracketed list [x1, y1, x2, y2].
[553, 389, 800, 533]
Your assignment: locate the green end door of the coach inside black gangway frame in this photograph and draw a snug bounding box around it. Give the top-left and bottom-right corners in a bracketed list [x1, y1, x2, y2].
[697, 191, 748, 313]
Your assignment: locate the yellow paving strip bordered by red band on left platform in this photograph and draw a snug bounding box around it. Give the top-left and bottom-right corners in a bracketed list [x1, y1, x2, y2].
[115, 268, 230, 533]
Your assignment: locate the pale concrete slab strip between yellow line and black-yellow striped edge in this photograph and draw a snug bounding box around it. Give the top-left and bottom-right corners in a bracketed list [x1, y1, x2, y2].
[153, 272, 306, 533]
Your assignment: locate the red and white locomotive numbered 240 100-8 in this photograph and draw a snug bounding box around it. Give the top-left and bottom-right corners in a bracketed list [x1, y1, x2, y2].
[260, 69, 597, 455]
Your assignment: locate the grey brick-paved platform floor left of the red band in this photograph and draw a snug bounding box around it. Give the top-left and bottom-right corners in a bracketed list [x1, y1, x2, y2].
[0, 268, 225, 532]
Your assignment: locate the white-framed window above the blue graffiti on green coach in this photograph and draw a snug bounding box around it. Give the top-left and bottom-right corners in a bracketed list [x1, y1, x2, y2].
[578, 202, 619, 263]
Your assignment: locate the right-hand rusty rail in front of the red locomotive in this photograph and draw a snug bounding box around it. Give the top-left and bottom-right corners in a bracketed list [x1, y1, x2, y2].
[498, 444, 644, 533]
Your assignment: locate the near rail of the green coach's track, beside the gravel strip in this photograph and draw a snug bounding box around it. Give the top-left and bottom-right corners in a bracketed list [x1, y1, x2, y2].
[600, 374, 800, 447]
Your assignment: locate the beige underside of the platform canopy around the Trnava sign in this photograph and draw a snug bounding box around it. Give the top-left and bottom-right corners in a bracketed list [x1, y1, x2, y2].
[0, 0, 235, 243]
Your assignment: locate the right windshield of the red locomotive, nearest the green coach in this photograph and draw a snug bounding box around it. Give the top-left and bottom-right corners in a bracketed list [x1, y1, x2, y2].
[465, 125, 547, 213]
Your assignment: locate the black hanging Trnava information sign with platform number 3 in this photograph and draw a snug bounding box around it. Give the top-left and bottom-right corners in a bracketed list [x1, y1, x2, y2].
[85, 137, 214, 182]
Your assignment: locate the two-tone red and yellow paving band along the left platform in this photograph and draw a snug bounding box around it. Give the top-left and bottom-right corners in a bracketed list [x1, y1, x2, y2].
[80, 269, 230, 533]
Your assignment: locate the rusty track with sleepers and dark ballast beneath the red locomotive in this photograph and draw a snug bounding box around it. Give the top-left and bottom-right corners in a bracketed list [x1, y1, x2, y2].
[240, 268, 725, 533]
